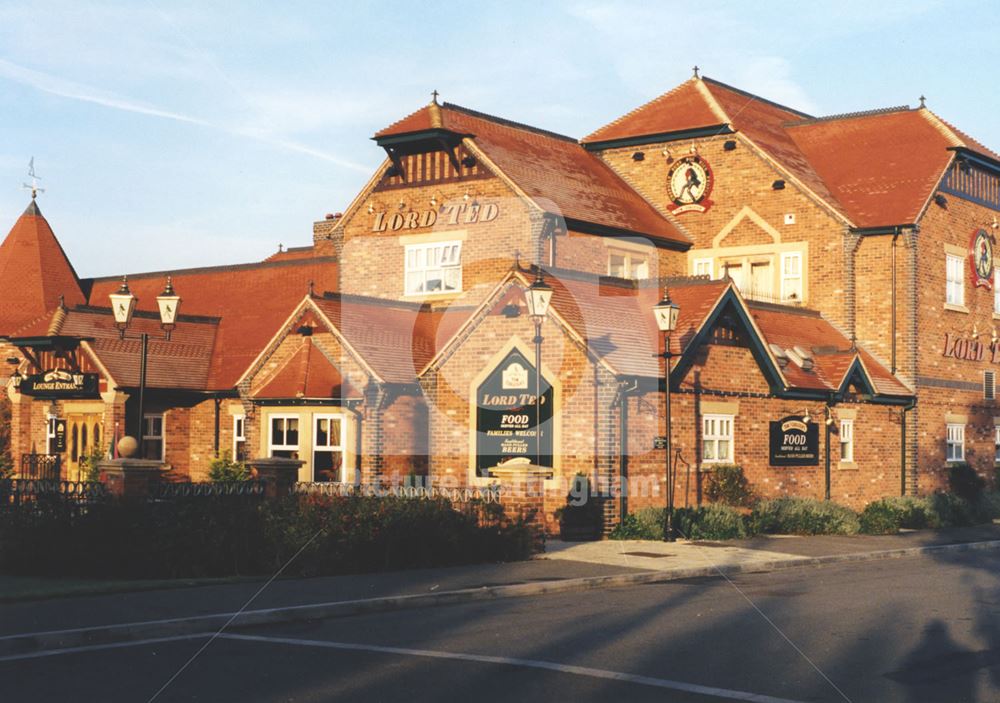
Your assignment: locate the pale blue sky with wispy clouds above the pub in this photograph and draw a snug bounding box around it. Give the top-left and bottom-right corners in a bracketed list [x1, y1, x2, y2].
[0, 0, 1000, 276]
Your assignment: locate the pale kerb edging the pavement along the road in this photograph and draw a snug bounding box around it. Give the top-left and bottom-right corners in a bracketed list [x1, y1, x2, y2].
[0, 540, 1000, 659]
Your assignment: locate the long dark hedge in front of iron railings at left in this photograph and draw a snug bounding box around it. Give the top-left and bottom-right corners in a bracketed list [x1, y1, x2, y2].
[0, 496, 536, 578]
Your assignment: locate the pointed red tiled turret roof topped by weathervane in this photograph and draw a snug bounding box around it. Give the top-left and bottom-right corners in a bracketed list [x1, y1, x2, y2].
[0, 201, 84, 334]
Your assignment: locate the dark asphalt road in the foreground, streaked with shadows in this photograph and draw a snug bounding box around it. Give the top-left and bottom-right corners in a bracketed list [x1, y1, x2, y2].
[0, 551, 1000, 703]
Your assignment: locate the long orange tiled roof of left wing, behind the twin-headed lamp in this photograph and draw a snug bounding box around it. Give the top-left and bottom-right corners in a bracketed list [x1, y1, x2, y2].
[89, 257, 339, 390]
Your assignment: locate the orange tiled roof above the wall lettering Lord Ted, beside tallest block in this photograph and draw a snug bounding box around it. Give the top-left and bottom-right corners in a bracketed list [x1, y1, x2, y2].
[375, 103, 691, 247]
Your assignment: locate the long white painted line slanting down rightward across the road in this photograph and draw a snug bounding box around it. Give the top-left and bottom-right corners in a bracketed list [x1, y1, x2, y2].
[219, 632, 801, 703]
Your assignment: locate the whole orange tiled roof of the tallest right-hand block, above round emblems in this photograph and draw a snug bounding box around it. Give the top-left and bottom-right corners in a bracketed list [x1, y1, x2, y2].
[583, 78, 1000, 229]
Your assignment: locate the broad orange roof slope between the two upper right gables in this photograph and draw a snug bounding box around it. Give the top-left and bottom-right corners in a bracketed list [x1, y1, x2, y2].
[787, 109, 953, 227]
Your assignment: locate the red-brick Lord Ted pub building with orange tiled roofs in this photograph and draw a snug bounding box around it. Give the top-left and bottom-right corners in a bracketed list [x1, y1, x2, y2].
[0, 76, 1000, 532]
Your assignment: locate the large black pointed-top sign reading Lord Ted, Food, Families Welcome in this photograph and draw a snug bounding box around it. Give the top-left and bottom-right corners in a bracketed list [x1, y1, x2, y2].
[476, 349, 552, 477]
